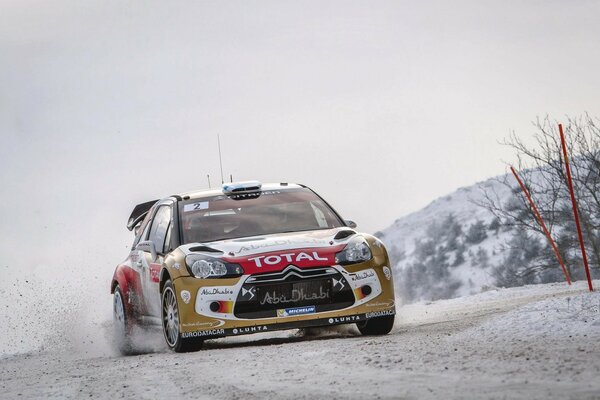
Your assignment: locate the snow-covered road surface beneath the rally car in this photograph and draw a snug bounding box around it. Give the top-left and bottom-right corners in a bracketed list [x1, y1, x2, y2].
[0, 282, 600, 400]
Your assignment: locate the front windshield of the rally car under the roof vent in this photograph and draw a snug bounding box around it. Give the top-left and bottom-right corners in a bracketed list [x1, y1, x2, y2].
[179, 188, 343, 244]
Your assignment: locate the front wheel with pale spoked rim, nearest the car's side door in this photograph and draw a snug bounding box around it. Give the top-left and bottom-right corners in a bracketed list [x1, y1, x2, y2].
[160, 280, 202, 353]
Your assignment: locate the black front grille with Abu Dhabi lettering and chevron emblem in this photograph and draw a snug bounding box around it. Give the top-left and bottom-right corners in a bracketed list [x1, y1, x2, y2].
[234, 266, 354, 319]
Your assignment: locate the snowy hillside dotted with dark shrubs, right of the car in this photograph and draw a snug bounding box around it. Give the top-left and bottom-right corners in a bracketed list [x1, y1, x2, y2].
[375, 173, 562, 302]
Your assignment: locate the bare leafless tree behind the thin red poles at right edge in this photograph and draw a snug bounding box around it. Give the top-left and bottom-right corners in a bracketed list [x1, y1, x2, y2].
[479, 114, 600, 278]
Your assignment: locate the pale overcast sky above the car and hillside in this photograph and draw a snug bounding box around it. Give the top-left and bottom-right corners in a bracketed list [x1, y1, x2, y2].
[0, 0, 600, 278]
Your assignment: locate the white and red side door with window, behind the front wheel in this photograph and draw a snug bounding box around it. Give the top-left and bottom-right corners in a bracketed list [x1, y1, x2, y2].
[141, 202, 173, 317]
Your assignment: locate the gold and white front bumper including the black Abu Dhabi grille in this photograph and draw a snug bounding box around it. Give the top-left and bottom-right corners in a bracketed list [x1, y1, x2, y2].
[173, 258, 395, 339]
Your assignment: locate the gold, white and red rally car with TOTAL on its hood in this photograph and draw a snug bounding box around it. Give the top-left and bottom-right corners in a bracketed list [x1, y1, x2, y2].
[110, 181, 395, 353]
